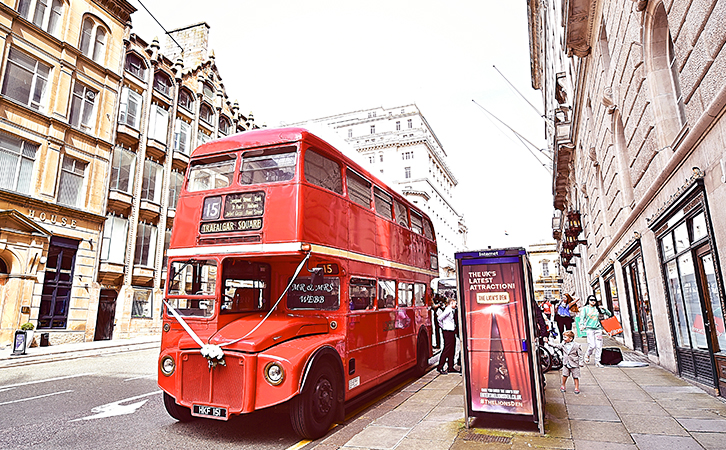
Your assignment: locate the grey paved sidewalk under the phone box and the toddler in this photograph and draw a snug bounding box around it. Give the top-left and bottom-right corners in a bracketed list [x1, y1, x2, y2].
[314, 339, 726, 450]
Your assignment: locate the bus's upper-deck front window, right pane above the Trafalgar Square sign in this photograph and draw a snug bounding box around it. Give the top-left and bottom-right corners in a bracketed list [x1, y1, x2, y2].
[239, 147, 297, 184]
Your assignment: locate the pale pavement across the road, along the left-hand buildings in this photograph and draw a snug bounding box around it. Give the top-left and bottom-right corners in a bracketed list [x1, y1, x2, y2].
[0, 336, 161, 369]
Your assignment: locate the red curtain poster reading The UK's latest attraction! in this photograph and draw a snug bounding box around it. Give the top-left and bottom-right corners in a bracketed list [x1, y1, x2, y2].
[459, 256, 534, 415]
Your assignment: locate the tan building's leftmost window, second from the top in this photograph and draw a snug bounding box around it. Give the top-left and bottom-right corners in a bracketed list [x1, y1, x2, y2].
[2, 48, 50, 111]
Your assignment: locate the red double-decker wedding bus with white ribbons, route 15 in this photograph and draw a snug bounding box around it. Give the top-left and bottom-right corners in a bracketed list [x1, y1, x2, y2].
[158, 128, 438, 439]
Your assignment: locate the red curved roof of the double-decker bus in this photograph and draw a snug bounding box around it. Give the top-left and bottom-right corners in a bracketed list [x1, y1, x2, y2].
[191, 127, 431, 225]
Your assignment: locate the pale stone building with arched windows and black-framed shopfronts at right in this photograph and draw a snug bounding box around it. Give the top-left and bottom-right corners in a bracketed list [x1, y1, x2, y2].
[528, 0, 726, 395]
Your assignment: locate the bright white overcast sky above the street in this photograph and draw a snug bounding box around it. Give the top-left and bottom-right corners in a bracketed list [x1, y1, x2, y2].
[128, 0, 553, 250]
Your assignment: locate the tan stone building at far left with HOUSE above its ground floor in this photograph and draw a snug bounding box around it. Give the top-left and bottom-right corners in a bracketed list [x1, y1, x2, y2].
[0, 0, 135, 345]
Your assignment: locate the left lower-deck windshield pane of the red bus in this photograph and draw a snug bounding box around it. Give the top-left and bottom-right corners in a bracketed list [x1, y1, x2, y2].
[166, 259, 217, 317]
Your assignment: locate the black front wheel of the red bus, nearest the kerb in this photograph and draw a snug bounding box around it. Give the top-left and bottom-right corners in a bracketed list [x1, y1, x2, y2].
[290, 362, 340, 440]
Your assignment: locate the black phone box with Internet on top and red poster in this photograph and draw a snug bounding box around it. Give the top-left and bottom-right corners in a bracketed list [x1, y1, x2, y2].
[456, 248, 544, 433]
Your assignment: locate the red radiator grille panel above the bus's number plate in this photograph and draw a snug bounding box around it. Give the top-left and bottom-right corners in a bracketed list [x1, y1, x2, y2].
[181, 351, 244, 411]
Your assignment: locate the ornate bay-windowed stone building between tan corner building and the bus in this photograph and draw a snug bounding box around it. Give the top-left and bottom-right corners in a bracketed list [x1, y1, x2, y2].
[94, 23, 255, 340]
